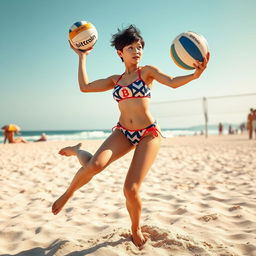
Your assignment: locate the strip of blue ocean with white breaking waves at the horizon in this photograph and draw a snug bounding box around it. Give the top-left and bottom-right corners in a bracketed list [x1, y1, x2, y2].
[0, 126, 224, 143]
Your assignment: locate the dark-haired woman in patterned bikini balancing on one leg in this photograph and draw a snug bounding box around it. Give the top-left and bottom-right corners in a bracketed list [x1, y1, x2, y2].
[52, 25, 210, 247]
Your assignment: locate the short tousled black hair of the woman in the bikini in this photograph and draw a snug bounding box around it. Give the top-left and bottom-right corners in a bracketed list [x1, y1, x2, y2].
[111, 25, 145, 51]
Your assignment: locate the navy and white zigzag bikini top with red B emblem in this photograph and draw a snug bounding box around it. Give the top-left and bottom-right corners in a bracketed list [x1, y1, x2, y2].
[113, 68, 151, 102]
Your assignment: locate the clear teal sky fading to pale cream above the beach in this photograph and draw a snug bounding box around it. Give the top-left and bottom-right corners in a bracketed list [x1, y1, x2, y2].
[0, 0, 256, 130]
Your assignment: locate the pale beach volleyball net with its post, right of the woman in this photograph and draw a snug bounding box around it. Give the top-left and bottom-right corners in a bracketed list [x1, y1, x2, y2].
[151, 93, 256, 133]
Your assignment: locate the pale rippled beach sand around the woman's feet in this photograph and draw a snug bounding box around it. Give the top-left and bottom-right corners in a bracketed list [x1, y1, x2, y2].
[0, 135, 256, 256]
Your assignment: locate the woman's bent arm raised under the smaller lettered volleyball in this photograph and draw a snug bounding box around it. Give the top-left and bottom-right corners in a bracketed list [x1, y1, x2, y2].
[70, 44, 115, 92]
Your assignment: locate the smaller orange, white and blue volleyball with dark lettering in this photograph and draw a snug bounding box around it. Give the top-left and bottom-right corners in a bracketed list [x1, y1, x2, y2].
[69, 21, 98, 50]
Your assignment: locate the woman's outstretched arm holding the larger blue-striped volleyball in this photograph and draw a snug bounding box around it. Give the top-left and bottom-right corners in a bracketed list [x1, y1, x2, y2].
[147, 53, 210, 88]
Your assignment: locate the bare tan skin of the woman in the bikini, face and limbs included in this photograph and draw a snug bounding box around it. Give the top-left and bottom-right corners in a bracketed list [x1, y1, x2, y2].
[52, 41, 210, 247]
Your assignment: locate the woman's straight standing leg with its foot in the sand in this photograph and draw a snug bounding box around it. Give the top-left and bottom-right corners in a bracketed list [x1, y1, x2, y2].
[124, 135, 161, 246]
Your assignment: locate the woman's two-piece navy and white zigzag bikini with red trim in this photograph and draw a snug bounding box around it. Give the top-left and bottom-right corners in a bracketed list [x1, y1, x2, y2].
[113, 68, 159, 146]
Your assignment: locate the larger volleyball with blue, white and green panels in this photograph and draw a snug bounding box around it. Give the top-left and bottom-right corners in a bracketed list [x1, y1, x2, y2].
[170, 31, 208, 70]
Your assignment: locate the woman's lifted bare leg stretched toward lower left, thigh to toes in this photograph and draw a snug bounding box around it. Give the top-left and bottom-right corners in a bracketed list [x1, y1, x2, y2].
[52, 130, 134, 214]
